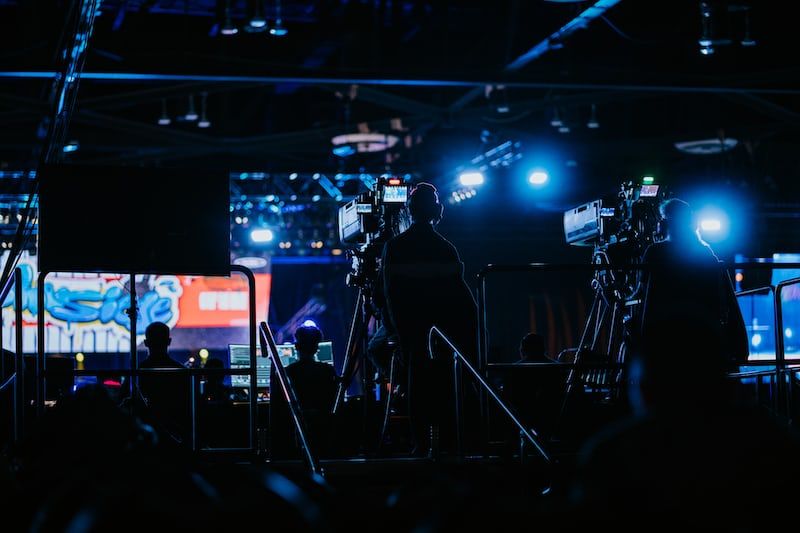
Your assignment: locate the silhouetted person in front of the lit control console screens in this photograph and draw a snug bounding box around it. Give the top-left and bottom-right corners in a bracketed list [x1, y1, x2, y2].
[270, 326, 337, 455]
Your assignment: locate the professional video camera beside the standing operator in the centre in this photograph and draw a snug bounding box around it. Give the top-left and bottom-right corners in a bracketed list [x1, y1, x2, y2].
[339, 176, 409, 288]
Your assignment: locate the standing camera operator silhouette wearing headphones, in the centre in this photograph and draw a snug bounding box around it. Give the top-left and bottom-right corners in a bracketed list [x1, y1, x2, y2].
[382, 183, 477, 454]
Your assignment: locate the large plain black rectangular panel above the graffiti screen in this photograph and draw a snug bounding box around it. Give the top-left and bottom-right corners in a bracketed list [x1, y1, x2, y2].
[39, 165, 230, 275]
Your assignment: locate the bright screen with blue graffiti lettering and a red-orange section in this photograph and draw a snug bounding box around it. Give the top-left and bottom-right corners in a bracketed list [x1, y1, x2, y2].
[0, 254, 271, 353]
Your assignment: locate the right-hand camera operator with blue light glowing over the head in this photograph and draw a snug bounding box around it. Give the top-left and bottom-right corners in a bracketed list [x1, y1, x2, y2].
[634, 198, 748, 368]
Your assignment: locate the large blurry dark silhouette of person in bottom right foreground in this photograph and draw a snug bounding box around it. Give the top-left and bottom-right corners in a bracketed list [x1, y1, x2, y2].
[567, 310, 800, 531]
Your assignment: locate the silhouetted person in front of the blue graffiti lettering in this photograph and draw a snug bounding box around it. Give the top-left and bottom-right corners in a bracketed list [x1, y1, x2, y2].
[139, 322, 191, 441]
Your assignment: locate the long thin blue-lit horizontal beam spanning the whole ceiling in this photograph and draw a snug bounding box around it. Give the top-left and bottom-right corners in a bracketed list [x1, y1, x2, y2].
[0, 71, 800, 95]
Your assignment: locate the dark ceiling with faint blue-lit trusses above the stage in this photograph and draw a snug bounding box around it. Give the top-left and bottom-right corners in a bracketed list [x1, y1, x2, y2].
[0, 0, 800, 256]
